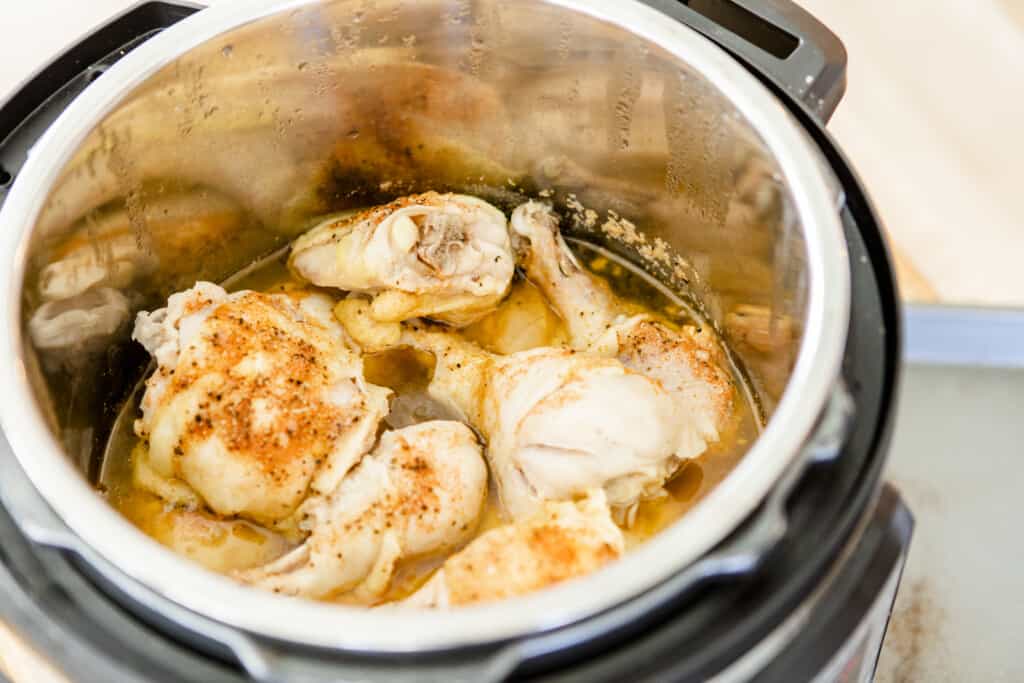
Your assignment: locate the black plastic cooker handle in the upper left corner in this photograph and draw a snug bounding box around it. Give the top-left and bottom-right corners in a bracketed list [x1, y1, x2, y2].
[0, 2, 201, 205]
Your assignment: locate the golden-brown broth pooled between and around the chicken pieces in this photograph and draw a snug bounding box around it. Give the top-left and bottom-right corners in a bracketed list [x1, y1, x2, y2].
[99, 242, 761, 604]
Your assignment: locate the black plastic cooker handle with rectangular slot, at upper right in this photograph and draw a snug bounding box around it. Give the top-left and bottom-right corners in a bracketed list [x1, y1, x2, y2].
[646, 0, 846, 122]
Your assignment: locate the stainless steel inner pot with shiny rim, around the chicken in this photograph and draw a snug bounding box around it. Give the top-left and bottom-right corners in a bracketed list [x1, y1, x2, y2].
[0, 0, 850, 651]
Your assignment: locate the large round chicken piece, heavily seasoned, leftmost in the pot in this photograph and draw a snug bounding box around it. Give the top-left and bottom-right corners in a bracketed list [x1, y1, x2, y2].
[134, 283, 390, 524]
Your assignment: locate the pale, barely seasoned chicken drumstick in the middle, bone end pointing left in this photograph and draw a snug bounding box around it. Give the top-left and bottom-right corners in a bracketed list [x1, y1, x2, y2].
[336, 309, 680, 519]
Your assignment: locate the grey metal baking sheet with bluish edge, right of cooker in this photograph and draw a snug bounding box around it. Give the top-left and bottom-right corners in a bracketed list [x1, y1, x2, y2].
[877, 307, 1024, 683]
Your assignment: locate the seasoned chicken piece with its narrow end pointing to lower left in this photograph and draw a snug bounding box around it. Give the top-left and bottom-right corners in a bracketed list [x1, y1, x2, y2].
[239, 421, 487, 600]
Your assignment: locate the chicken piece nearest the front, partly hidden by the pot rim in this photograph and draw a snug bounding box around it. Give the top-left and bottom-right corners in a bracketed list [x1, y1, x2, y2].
[401, 492, 624, 607]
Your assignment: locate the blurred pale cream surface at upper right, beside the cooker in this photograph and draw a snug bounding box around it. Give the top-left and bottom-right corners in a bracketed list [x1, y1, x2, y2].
[801, 0, 1024, 306]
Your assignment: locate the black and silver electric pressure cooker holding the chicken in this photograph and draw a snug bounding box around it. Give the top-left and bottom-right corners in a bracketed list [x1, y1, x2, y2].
[0, 0, 912, 681]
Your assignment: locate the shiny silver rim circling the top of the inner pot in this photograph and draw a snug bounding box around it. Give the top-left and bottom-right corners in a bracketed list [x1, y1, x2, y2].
[0, 0, 850, 652]
